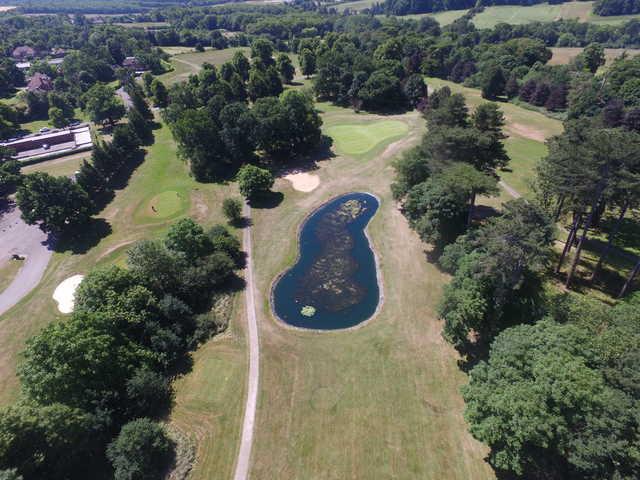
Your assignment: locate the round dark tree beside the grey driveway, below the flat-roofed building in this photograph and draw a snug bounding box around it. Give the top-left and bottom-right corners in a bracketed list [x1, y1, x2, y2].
[16, 172, 91, 233]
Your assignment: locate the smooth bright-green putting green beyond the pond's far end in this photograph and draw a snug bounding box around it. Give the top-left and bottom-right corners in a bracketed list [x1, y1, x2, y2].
[326, 120, 409, 156]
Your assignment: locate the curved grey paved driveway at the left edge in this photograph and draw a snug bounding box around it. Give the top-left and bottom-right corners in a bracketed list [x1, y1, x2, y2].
[0, 202, 52, 315]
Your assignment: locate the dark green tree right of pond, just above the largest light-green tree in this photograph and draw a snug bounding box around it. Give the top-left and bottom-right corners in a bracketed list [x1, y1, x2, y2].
[439, 200, 554, 350]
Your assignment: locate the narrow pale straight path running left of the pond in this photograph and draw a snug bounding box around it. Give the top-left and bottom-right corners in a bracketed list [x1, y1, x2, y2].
[233, 205, 260, 480]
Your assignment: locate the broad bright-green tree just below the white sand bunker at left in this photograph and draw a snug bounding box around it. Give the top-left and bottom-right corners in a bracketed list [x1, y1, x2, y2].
[18, 312, 154, 414]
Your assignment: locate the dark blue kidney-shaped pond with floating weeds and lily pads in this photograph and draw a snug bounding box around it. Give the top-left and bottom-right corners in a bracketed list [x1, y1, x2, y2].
[272, 193, 380, 330]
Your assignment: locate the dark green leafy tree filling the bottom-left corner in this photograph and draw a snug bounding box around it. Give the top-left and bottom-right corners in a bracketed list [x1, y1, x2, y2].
[0, 403, 96, 480]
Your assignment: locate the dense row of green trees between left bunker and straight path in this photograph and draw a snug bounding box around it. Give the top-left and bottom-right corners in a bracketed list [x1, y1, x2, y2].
[0, 219, 243, 480]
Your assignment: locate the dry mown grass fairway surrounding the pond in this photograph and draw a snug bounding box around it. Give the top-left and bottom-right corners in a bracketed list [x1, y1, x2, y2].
[245, 107, 493, 480]
